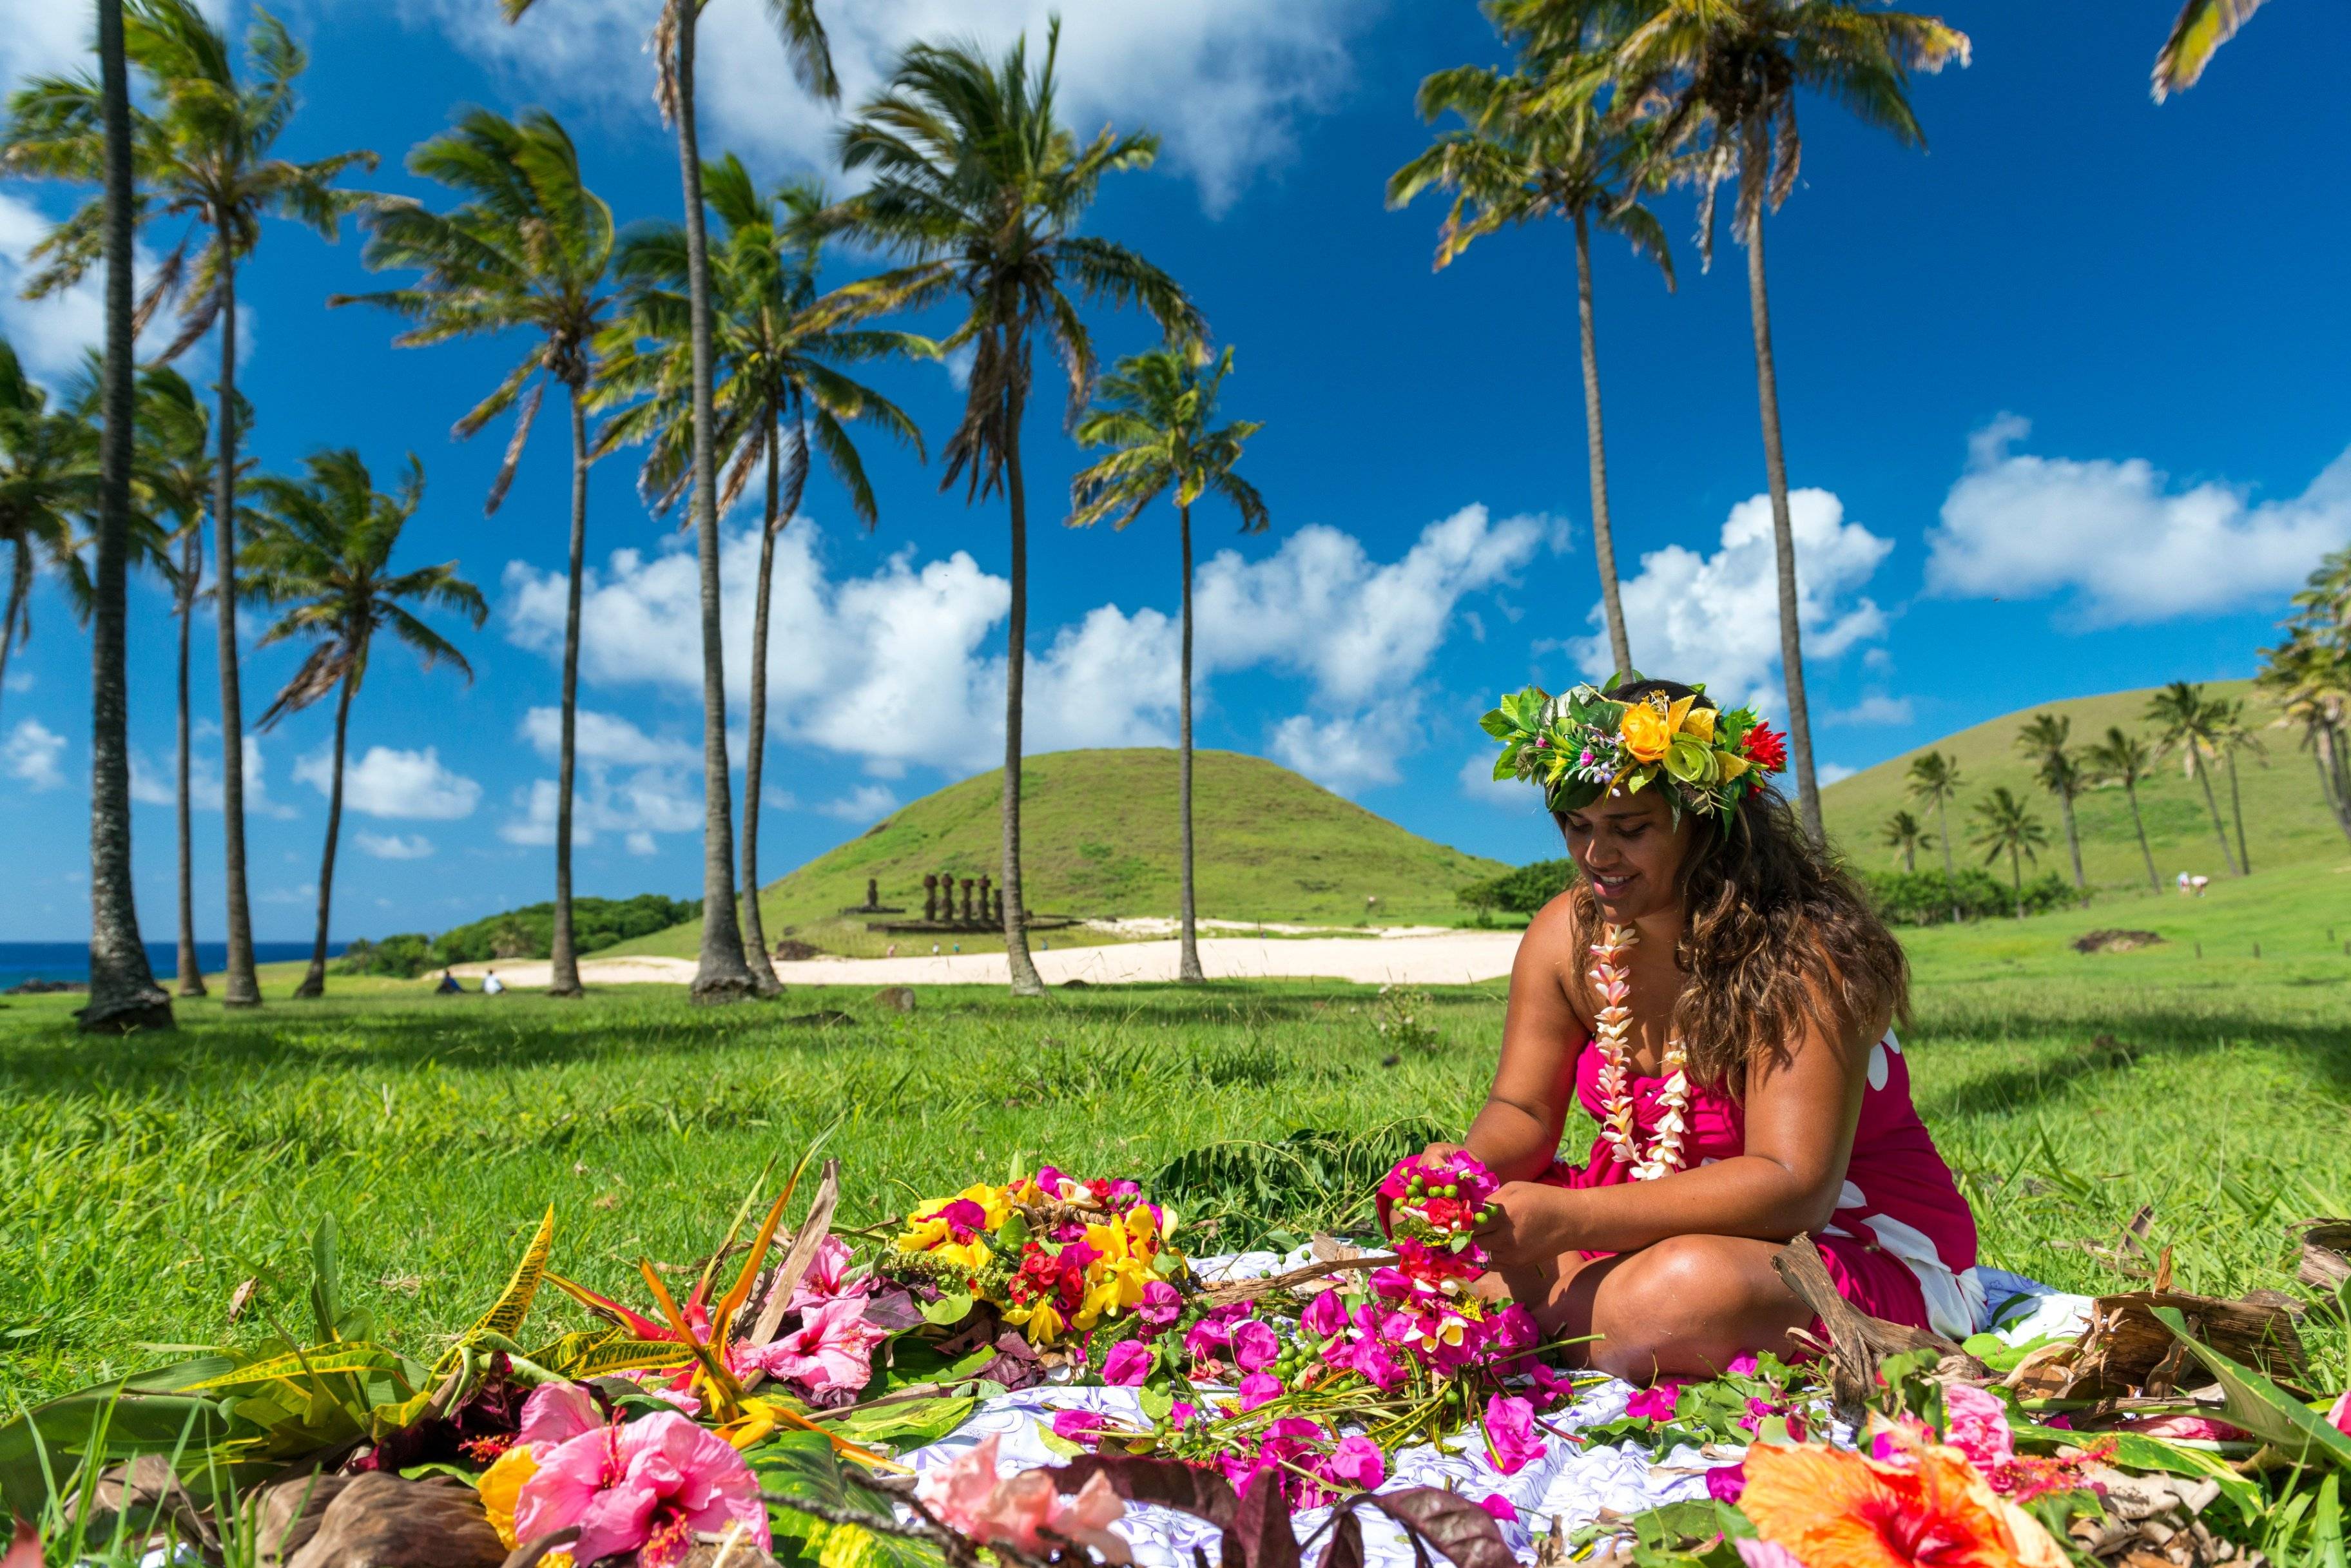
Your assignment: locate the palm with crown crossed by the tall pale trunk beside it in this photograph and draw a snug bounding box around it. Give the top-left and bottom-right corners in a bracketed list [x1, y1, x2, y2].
[597, 153, 933, 994]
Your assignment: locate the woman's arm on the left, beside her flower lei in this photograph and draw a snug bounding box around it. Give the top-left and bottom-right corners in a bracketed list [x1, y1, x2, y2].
[1467, 893, 1592, 1183]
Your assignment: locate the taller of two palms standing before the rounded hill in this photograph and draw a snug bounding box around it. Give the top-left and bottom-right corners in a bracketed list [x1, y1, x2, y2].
[839, 21, 1206, 997]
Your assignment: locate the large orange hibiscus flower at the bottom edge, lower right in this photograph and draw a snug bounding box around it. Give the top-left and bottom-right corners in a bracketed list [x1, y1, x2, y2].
[1740, 1444, 2067, 1568]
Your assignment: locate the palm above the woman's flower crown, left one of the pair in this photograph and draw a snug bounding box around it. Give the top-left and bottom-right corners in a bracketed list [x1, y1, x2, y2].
[1387, 54, 1674, 670]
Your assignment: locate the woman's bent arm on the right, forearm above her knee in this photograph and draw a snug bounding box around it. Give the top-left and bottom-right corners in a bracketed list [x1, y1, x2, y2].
[1481, 992, 1886, 1270]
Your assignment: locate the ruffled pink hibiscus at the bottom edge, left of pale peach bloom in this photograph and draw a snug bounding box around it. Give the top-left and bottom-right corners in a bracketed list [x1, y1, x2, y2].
[515, 1411, 769, 1568]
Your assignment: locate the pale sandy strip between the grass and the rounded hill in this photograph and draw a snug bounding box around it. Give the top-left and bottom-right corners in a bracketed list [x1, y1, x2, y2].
[456, 931, 1519, 990]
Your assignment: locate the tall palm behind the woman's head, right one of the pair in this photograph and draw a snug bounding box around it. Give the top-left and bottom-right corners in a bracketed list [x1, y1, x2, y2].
[1608, 0, 1968, 842]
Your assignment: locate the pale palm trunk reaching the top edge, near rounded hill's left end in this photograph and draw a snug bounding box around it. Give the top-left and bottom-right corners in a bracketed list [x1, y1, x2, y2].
[677, 0, 752, 1002]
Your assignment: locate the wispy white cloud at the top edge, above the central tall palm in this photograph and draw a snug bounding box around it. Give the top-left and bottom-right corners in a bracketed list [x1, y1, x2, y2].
[360, 0, 1380, 211]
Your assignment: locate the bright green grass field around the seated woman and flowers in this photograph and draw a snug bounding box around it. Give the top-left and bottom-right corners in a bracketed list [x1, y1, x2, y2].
[0, 858, 2351, 1399]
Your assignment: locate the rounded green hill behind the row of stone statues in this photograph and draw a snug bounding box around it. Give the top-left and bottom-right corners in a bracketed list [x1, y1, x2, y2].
[614, 748, 1507, 957]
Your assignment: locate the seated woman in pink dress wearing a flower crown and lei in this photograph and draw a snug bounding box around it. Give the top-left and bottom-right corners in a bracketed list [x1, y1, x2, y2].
[1439, 677, 1982, 1382]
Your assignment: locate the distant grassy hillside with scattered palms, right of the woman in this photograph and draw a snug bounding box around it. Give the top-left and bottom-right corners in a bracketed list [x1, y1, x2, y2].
[1822, 679, 2351, 898]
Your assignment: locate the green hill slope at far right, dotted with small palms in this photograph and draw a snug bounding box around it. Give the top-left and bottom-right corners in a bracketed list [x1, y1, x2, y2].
[1820, 682, 2351, 889]
